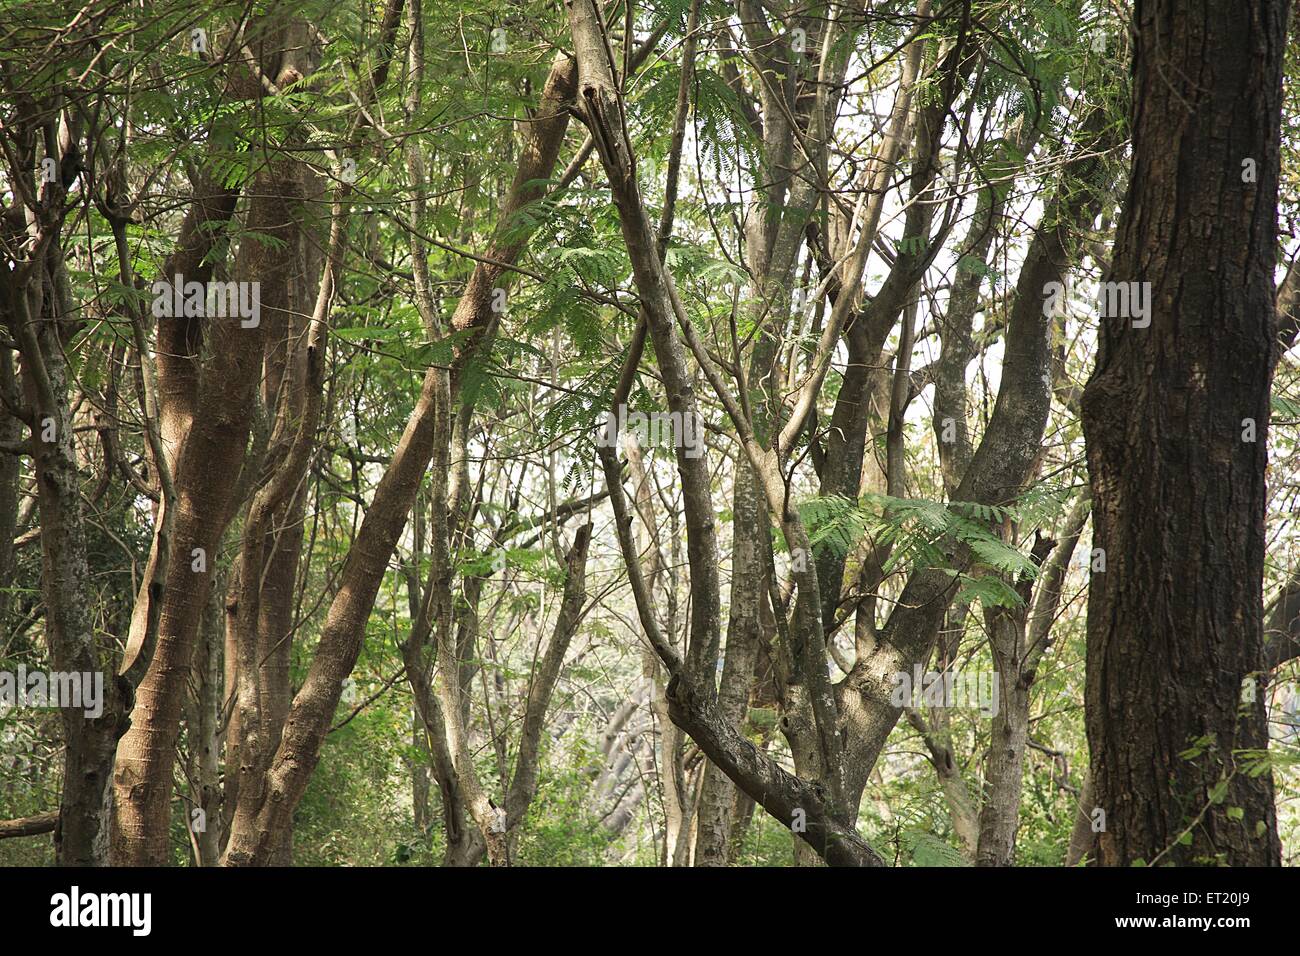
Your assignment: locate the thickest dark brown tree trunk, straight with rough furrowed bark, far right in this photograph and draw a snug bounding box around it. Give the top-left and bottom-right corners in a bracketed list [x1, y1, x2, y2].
[1083, 0, 1287, 866]
